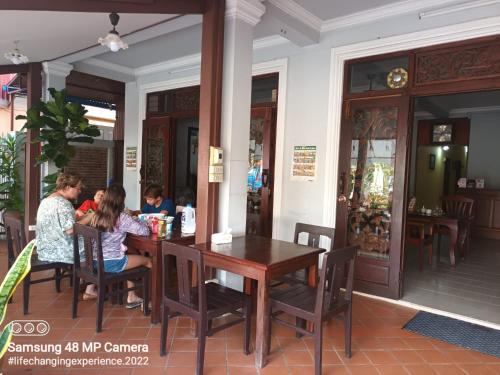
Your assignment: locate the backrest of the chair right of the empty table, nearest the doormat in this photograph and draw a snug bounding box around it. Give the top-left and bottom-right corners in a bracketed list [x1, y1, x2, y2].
[314, 245, 360, 317]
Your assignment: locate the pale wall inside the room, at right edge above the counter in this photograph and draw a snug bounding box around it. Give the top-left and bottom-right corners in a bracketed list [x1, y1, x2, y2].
[467, 112, 500, 189]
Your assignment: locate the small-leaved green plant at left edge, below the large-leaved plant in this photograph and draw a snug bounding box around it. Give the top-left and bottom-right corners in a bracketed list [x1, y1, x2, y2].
[0, 134, 24, 212]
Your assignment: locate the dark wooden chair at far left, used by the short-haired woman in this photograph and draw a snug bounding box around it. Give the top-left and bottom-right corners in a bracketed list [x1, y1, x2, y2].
[4, 214, 72, 315]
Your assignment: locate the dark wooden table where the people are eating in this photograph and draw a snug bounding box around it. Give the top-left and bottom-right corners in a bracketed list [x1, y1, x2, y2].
[125, 228, 195, 324]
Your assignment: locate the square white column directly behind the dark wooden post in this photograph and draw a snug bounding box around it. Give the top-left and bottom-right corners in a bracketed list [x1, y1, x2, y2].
[218, 0, 265, 235]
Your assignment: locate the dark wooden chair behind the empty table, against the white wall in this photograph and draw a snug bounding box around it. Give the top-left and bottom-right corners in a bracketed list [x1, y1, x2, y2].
[271, 223, 335, 287]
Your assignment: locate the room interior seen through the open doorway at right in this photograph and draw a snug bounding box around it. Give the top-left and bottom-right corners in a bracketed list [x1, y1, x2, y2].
[403, 91, 500, 324]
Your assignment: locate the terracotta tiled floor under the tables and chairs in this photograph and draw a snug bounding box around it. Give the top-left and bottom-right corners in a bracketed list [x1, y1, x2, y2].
[0, 243, 500, 375]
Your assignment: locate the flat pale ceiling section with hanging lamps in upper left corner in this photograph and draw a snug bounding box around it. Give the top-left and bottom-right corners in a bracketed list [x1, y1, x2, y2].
[0, 10, 174, 65]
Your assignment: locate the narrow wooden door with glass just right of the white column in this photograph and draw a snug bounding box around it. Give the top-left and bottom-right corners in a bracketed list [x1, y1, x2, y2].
[246, 107, 276, 238]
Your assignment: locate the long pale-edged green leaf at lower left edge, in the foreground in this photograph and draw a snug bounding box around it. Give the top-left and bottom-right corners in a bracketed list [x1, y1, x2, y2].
[0, 240, 35, 324]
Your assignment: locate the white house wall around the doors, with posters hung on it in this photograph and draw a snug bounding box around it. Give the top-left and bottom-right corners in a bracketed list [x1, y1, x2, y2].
[124, 9, 500, 240]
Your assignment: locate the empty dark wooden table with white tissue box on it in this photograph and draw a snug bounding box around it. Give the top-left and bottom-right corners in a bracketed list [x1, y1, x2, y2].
[194, 236, 325, 368]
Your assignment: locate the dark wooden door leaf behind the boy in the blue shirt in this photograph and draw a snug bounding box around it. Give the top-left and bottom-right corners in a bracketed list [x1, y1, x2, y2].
[141, 116, 175, 201]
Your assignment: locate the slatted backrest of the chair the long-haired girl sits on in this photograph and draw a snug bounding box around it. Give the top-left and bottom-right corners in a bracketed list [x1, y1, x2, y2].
[73, 223, 104, 275]
